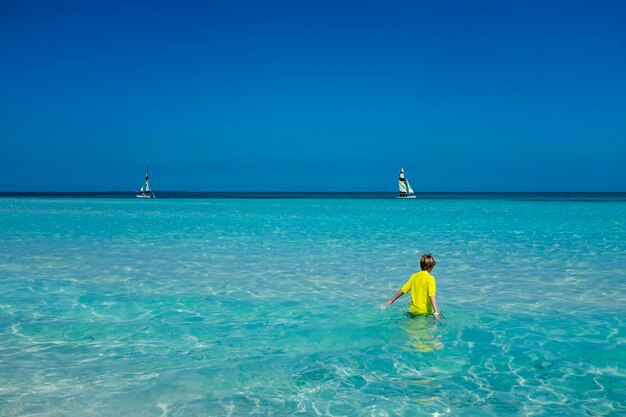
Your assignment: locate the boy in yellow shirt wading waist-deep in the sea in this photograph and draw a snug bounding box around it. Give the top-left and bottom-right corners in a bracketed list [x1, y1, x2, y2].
[384, 253, 439, 320]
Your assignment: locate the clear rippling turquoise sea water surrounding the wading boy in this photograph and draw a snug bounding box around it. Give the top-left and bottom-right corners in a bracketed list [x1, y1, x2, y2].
[0, 196, 626, 416]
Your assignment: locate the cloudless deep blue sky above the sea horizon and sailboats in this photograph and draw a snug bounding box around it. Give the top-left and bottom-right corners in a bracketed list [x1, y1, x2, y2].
[0, 0, 626, 191]
